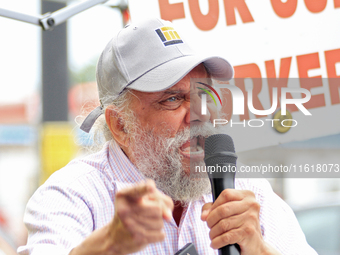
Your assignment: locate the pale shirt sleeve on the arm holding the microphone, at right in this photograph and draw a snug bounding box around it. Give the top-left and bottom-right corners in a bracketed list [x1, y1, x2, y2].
[243, 179, 317, 255]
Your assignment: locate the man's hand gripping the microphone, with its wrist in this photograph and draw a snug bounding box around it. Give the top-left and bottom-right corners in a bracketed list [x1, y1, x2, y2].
[201, 189, 278, 255]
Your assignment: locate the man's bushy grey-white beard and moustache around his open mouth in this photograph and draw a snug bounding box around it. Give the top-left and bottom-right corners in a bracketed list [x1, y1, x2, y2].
[125, 112, 217, 206]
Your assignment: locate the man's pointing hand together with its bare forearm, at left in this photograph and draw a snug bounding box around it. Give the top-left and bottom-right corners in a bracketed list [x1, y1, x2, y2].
[70, 180, 174, 255]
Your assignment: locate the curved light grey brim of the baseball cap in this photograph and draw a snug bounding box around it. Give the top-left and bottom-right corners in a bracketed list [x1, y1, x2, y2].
[127, 55, 234, 92]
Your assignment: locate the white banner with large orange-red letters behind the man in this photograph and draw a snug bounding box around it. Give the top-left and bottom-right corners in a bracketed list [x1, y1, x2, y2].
[129, 0, 340, 151]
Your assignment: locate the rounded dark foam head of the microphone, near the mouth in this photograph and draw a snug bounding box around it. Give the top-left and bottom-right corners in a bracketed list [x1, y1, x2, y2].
[204, 134, 237, 165]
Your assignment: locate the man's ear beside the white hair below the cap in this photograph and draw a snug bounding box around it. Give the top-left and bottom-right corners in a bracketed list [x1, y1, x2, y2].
[105, 105, 129, 147]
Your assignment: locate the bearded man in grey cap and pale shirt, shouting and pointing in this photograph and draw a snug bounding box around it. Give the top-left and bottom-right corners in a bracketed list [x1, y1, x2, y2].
[18, 19, 316, 255]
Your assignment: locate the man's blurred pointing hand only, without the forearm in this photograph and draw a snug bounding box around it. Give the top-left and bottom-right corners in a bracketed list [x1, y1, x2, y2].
[111, 180, 174, 254]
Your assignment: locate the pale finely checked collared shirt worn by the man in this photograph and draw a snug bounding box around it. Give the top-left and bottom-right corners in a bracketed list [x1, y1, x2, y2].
[18, 141, 317, 255]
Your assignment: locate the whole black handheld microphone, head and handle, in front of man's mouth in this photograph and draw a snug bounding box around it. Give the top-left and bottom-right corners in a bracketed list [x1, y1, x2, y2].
[204, 134, 240, 255]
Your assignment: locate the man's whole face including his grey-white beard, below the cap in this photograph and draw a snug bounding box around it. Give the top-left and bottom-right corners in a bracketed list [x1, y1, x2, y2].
[124, 65, 216, 203]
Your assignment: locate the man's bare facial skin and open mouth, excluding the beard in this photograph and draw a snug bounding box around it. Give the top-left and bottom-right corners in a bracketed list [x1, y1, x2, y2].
[130, 64, 218, 164]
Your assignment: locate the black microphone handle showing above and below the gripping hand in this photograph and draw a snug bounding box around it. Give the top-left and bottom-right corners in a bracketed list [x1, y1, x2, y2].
[209, 164, 241, 255]
